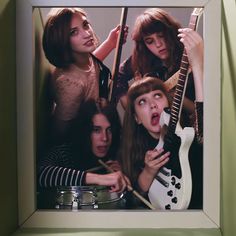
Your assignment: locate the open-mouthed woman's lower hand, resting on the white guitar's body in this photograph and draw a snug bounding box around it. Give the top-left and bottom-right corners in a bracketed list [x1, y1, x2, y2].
[144, 149, 170, 177]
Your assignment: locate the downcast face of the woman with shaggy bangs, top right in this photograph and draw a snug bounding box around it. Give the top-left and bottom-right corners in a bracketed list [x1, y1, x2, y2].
[143, 33, 169, 61]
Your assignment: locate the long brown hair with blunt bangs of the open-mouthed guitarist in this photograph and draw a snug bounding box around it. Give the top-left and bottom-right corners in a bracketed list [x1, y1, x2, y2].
[120, 76, 171, 184]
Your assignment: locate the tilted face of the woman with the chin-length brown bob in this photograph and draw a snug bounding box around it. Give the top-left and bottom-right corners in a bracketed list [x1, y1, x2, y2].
[70, 13, 96, 53]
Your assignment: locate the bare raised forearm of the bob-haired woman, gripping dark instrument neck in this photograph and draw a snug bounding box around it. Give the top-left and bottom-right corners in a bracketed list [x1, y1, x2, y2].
[93, 25, 128, 61]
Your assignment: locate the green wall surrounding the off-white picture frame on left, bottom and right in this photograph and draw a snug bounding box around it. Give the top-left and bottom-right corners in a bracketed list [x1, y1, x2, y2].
[0, 0, 236, 236]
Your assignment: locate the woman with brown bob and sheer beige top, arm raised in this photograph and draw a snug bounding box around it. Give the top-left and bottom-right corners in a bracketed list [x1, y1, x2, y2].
[43, 8, 127, 141]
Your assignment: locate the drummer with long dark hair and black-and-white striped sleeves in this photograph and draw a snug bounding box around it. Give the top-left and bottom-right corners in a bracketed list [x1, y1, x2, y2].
[37, 100, 129, 208]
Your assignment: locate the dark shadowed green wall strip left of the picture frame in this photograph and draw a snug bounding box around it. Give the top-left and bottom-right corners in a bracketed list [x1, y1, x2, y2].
[0, 0, 17, 236]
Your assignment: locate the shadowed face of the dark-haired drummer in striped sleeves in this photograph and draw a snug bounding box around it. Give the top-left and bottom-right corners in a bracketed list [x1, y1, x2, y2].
[91, 114, 112, 157]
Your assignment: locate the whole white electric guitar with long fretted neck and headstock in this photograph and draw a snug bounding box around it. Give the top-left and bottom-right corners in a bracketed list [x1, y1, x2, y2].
[148, 8, 203, 210]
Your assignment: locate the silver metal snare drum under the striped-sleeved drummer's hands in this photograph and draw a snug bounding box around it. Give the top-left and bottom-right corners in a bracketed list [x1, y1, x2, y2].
[55, 186, 126, 210]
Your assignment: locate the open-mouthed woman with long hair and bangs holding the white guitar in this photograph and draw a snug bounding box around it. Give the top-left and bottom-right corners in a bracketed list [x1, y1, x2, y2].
[121, 76, 203, 208]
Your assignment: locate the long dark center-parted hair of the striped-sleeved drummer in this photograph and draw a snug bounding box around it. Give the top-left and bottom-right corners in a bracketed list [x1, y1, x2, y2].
[69, 99, 121, 167]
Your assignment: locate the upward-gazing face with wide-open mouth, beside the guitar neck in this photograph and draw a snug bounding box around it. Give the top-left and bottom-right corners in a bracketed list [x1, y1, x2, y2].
[134, 90, 169, 139]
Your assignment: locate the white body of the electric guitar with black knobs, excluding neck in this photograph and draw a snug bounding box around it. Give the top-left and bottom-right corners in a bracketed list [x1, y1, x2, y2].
[148, 111, 194, 210]
